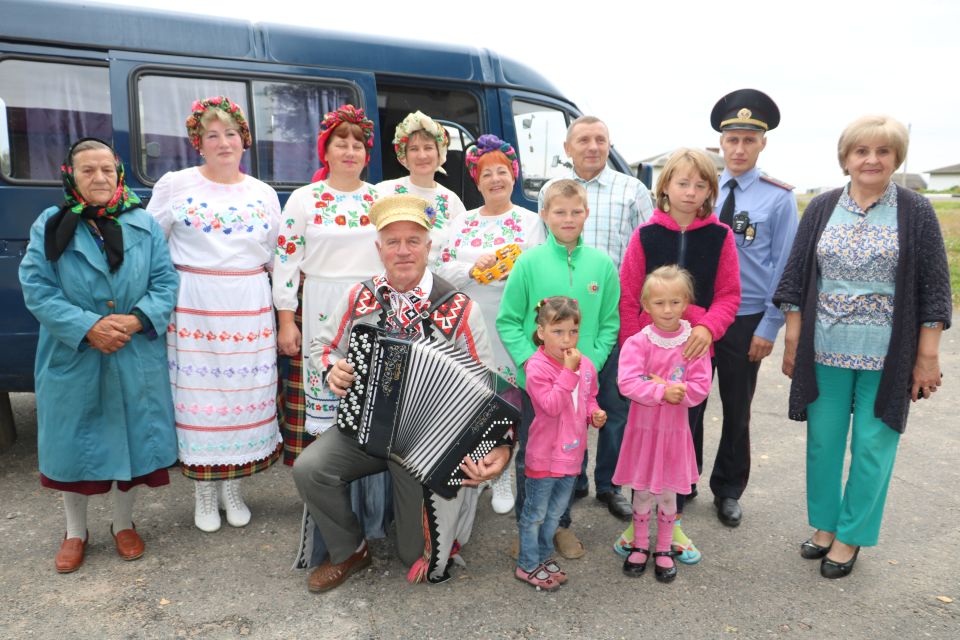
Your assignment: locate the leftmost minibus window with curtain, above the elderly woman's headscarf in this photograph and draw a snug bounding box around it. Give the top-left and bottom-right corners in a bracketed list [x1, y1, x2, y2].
[0, 58, 113, 182]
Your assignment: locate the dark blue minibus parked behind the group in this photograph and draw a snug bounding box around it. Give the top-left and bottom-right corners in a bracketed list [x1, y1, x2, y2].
[0, 0, 644, 436]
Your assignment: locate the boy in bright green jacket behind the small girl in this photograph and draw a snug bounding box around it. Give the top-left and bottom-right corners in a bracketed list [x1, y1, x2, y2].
[497, 180, 620, 558]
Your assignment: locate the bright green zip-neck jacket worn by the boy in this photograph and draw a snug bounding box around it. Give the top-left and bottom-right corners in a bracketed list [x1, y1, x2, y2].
[497, 234, 620, 388]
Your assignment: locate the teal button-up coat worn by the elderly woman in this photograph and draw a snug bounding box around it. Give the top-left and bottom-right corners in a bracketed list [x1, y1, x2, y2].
[20, 207, 179, 482]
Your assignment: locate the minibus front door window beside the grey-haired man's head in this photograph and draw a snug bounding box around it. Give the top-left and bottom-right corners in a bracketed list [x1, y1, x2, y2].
[513, 100, 571, 200]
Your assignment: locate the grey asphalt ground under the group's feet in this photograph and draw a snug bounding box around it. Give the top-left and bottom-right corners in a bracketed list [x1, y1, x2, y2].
[0, 331, 960, 640]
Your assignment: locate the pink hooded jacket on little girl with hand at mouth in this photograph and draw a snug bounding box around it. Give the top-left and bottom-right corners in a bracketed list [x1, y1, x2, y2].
[524, 347, 600, 476]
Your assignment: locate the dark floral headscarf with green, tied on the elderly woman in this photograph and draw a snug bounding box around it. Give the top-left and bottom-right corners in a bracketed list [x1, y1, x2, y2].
[43, 138, 140, 272]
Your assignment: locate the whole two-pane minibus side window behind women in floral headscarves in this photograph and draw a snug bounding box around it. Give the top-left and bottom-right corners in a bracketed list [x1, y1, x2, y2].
[137, 74, 356, 186]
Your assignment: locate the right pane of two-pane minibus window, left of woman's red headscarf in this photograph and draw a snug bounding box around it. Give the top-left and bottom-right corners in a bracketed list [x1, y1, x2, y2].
[253, 80, 356, 186]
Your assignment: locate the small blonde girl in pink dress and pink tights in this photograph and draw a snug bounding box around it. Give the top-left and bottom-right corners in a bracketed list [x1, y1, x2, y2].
[613, 265, 711, 582]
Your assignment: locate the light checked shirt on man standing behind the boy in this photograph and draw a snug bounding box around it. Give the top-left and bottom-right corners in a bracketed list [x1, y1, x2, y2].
[537, 166, 653, 271]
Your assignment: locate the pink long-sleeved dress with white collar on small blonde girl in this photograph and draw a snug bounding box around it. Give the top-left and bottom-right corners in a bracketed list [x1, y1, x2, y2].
[613, 320, 711, 495]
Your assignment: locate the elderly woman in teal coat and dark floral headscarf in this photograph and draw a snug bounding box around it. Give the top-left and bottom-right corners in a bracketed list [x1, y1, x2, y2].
[20, 138, 178, 573]
